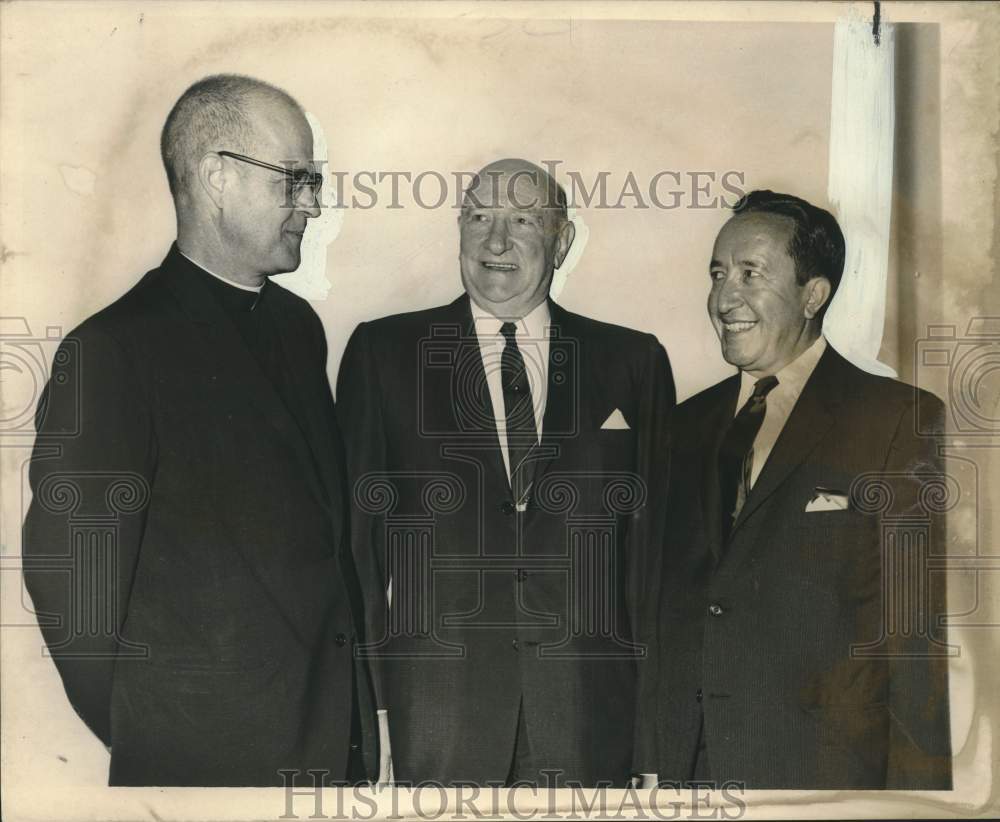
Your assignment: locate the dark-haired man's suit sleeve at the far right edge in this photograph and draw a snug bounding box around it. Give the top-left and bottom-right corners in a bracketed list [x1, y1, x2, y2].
[883, 392, 951, 790]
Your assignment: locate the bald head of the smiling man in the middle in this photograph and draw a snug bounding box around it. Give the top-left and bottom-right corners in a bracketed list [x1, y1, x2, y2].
[459, 161, 573, 319]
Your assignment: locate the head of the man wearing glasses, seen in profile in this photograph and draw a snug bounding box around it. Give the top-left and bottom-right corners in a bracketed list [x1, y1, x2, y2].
[162, 74, 320, 285]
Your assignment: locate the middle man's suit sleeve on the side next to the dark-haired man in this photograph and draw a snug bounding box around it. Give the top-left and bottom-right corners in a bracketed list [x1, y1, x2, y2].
[628, 337, 677, 773]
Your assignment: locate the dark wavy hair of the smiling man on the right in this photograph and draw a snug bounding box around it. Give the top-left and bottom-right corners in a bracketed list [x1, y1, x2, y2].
[733, 189, 845, 317]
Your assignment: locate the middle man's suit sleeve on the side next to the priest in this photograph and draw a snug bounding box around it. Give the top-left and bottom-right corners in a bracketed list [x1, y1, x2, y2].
[337, 323, 388, 708]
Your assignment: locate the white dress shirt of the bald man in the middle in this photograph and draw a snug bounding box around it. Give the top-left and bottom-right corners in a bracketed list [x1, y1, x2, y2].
[472, 300, 551, 479]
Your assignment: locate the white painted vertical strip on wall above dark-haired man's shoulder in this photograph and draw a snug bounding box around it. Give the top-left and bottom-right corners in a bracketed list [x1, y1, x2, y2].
[823, 13, 896, 376]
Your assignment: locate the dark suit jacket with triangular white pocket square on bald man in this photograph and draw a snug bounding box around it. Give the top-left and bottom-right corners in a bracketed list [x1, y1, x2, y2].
[337, 296, 674, 784]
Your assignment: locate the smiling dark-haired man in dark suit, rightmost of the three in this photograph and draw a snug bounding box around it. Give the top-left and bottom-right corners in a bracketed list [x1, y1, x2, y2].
[641, 191, 951, 789]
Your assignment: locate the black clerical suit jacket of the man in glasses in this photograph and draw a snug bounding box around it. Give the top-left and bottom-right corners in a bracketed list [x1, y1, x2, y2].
[24, 248, 371, 785]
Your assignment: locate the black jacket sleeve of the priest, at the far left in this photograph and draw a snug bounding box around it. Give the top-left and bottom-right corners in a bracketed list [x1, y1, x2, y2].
[22, 325, 155, 745]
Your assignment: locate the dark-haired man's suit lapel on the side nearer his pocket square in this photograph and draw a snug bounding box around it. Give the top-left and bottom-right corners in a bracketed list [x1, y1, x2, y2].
[733, 345, 842, 534]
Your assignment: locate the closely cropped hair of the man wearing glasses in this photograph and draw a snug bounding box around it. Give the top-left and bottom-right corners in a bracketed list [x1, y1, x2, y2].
[160, 74, 304, 198]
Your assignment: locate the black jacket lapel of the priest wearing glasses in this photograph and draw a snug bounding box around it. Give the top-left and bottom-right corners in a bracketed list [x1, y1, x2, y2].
[162, 247, 329, 508]
